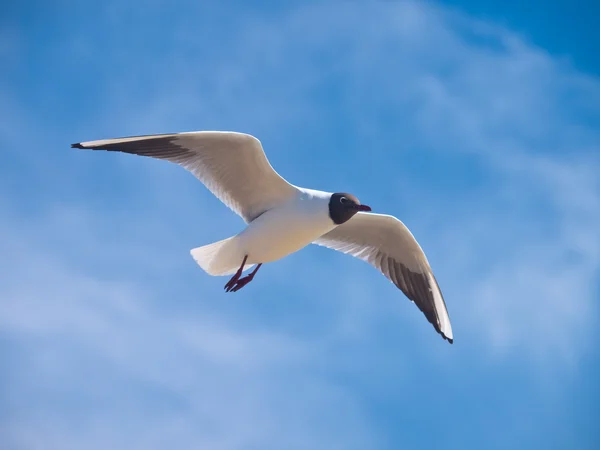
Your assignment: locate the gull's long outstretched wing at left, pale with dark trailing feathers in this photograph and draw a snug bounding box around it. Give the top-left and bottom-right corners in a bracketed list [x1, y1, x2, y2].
[71, 131, 297, 222]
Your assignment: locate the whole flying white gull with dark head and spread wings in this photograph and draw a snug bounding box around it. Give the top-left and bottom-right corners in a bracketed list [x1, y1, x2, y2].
[71, 131, 453, 343]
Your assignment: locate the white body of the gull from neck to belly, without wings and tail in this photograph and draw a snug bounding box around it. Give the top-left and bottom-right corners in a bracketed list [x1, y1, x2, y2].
[238, 189, 336, 264]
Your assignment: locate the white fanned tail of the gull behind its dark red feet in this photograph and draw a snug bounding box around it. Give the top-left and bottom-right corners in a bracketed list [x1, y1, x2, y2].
[190, 236, 254, 276]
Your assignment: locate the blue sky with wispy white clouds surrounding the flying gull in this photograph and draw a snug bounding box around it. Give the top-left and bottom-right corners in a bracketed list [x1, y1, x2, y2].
[0, 0, 600, 450]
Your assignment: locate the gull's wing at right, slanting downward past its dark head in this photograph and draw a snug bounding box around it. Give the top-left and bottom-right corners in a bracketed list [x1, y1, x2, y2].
[314, 212, 453, 343]
